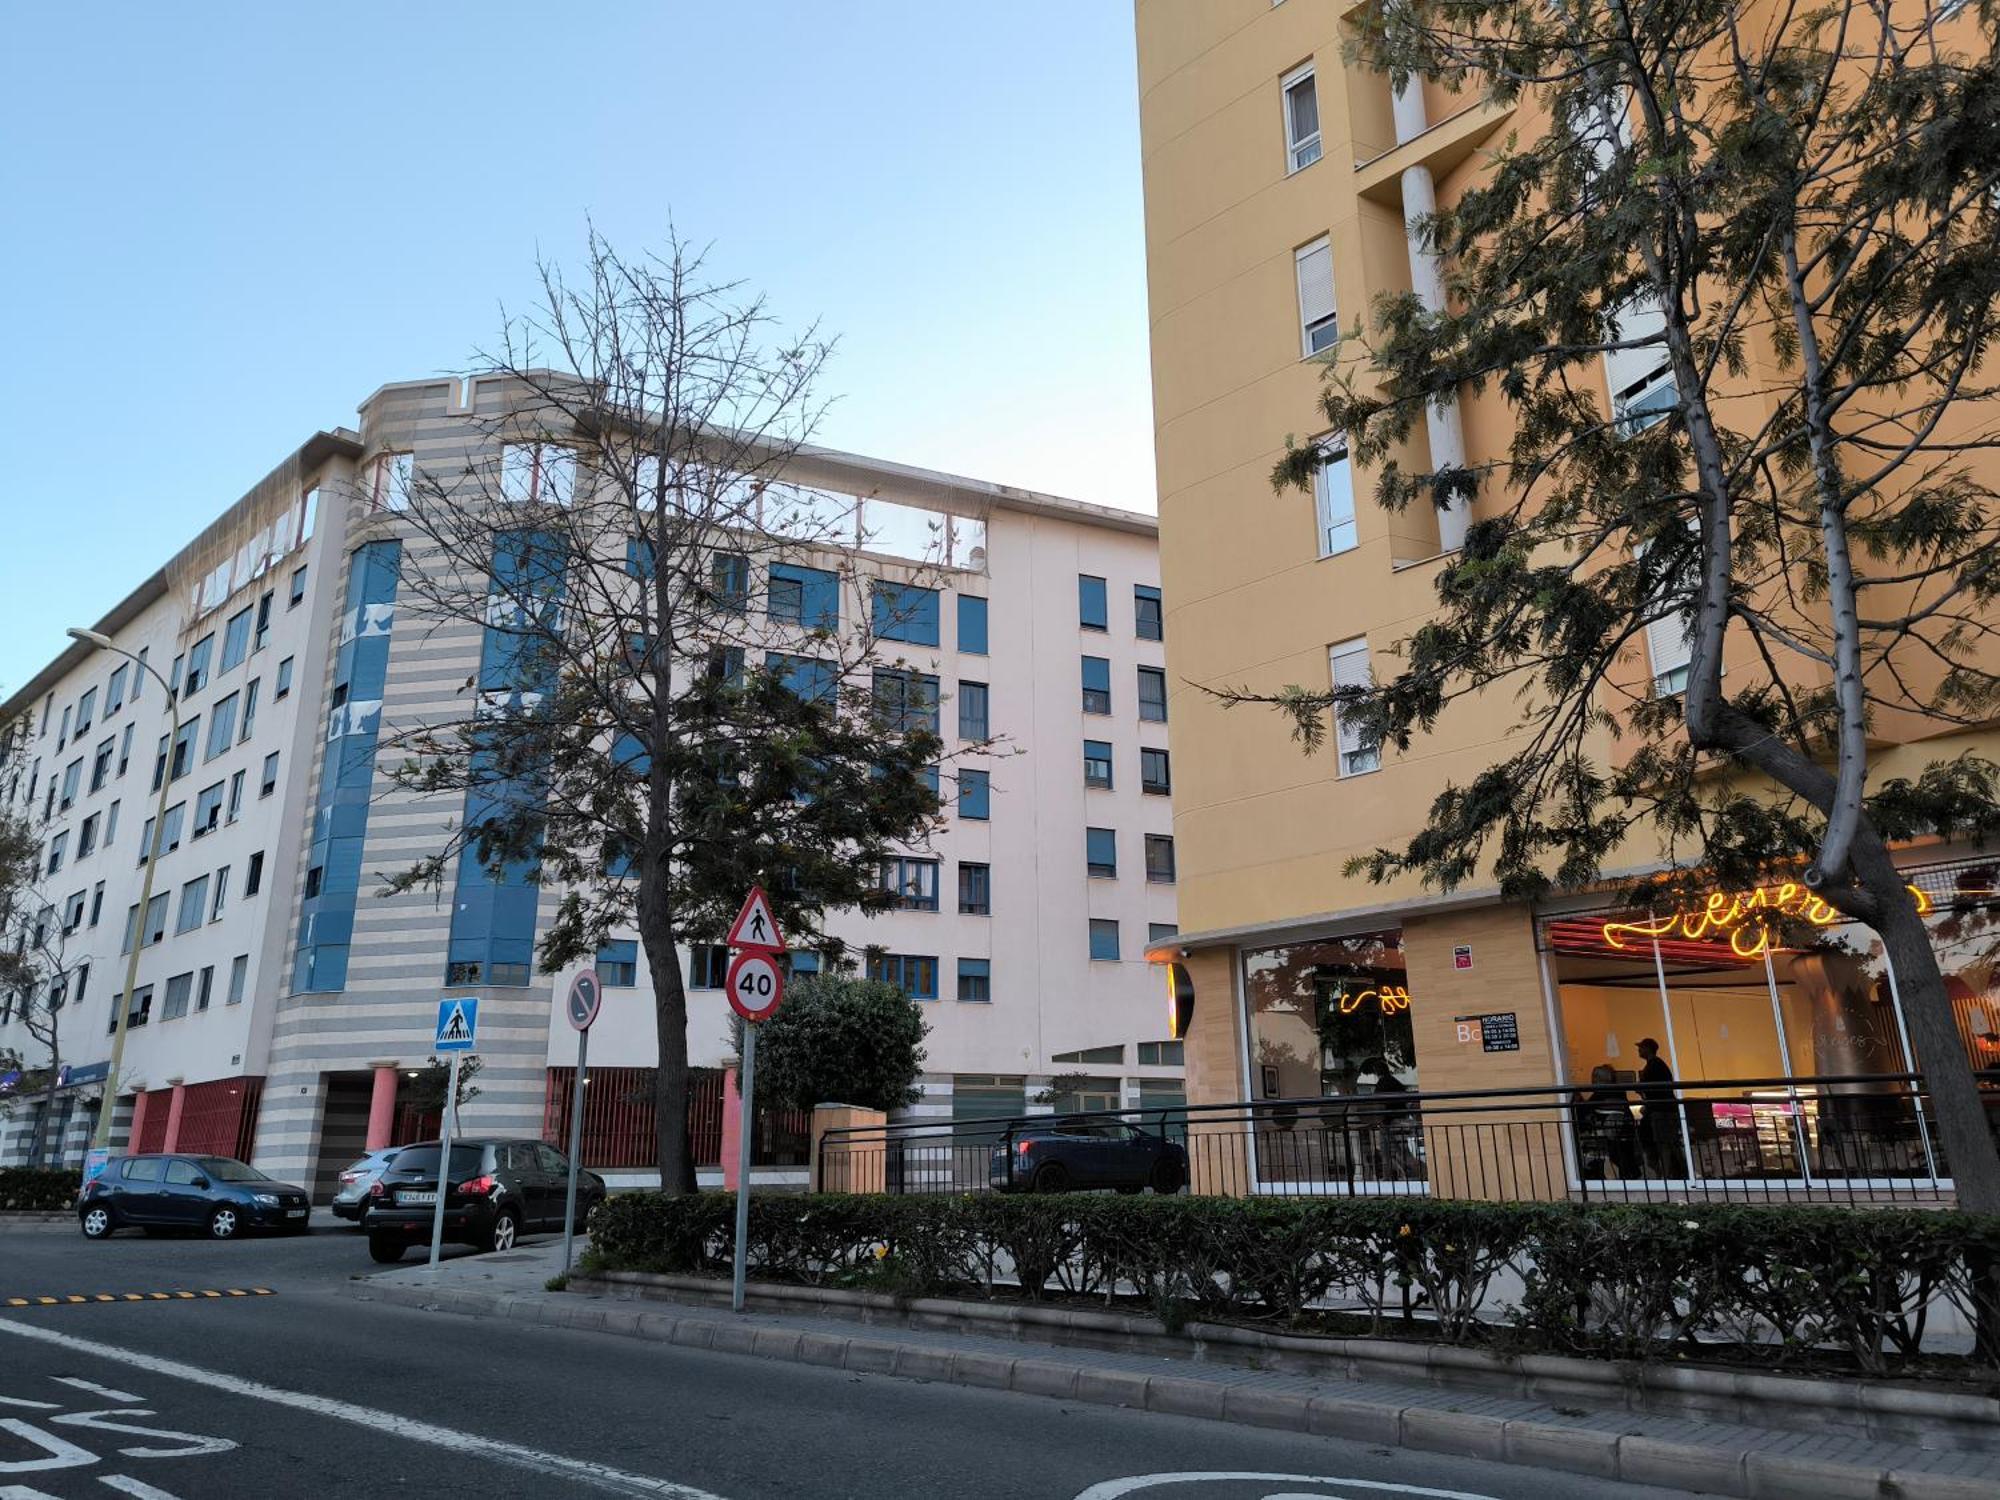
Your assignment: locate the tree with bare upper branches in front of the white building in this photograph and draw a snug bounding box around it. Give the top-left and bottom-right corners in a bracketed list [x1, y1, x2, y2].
[388, 236, 968, 1190]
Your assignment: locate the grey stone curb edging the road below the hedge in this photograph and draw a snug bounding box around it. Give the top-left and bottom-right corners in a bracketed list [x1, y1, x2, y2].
[344, 1278, 1994, 1500]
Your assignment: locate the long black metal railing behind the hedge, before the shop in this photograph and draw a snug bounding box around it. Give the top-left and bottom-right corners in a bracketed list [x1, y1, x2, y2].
[816, 1072, 2000, 1204]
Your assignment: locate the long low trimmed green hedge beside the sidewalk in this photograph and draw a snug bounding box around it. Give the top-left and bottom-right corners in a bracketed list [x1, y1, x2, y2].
[590, 1192, 2000, 1374]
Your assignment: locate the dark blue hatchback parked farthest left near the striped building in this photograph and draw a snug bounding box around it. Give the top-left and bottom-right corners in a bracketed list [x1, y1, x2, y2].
[76, 1152, 312, 1240]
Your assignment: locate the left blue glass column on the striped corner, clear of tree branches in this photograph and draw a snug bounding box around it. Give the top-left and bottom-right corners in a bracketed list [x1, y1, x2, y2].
[292, 542, 402, 994]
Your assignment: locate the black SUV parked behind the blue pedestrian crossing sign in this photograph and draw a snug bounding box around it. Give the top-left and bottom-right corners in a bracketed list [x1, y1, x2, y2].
[362, 1140, 606, 1264]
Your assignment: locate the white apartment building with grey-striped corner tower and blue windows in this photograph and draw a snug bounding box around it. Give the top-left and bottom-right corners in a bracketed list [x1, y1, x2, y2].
[0, 380, 1182, 1192]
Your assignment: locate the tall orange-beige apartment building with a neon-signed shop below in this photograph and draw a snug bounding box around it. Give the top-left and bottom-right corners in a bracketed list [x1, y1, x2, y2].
[1136, 0, 2000, 1192]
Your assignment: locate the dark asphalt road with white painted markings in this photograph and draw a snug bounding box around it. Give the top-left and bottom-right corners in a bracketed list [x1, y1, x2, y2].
[0, 1230, 1696, 1500]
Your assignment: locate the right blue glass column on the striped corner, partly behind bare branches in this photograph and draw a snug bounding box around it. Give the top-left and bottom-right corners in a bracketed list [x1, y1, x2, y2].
[444, 532, 564, 984]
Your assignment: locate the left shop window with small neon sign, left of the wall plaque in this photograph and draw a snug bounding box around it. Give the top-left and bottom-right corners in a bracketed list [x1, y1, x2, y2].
[1244, 928, 1424, 1190]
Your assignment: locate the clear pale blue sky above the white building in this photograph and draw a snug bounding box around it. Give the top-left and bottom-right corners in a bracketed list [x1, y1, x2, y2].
[0, 0, 1154, 696]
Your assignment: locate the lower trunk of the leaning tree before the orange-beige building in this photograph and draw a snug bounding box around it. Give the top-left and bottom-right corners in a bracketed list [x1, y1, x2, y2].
[1856, 862, 2000, 1214]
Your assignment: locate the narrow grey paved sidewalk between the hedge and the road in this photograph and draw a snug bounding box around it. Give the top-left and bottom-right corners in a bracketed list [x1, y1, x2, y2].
[348, 1238, 2000, 1500]
